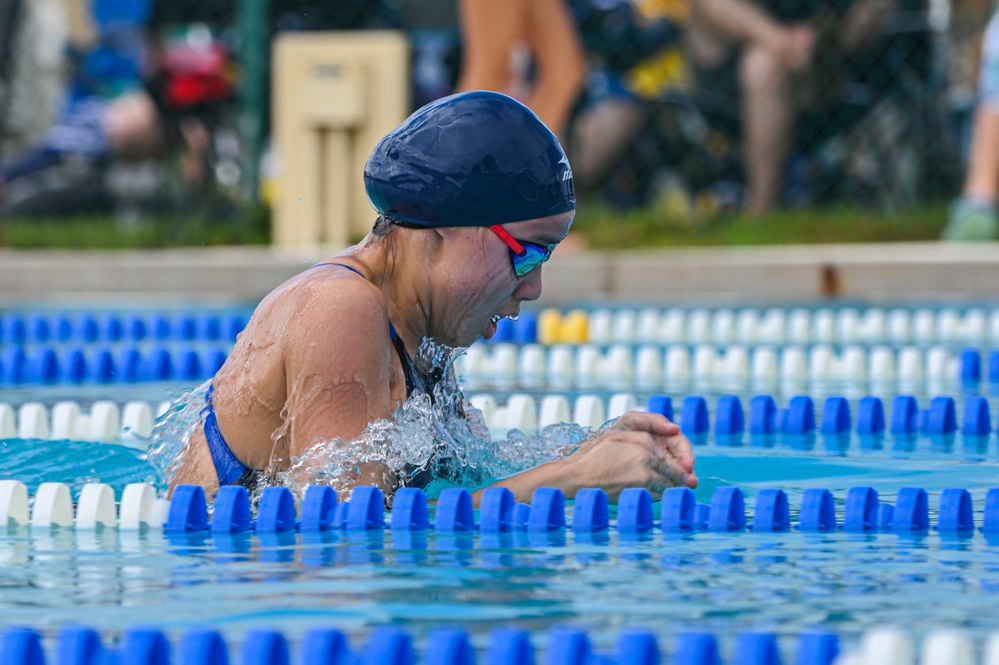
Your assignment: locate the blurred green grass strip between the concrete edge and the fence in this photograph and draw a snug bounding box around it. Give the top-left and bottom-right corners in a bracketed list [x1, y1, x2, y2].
[0, 201, 947, 249]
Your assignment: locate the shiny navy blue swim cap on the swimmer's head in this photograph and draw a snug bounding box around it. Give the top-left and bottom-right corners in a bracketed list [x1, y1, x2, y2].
[364, 90, 576, 227]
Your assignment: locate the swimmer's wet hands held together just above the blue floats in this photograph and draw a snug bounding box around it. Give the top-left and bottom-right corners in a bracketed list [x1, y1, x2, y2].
[561, 411, 697, 499]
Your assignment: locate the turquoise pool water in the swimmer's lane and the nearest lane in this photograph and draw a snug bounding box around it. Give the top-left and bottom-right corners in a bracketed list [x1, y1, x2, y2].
[0, 440, 999, 653]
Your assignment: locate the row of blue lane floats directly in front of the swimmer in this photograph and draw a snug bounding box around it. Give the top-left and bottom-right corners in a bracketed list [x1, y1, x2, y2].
[152, 485, 999, 536]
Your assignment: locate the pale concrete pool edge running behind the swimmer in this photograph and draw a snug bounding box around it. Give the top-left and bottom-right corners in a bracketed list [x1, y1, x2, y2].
[0, 242, 999, 306]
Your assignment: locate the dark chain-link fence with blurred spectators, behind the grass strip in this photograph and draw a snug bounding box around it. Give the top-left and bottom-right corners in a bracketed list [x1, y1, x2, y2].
[0, 0, 993, 227]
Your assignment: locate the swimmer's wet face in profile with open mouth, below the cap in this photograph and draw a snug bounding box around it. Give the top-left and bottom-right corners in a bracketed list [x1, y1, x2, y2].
[430, 212, 574, 346]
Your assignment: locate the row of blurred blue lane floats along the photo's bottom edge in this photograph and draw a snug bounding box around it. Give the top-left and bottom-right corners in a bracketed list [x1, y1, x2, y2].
[0, 612, 936, 665]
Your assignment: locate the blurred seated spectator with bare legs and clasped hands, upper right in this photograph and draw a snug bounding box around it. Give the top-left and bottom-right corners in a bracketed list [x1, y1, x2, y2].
[688, 0, 894, 213]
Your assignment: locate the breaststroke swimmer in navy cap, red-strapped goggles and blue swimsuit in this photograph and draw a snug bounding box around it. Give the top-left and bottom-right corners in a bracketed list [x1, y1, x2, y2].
[169, 91, 697, 503]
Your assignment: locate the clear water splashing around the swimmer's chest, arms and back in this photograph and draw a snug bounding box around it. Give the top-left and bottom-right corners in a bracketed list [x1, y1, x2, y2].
[147, 338, 593, 499]
